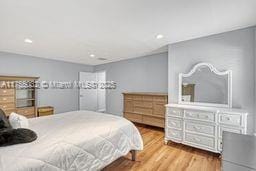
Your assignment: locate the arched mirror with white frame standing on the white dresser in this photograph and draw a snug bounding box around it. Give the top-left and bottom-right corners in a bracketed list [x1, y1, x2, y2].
[179, 63, 232, 107]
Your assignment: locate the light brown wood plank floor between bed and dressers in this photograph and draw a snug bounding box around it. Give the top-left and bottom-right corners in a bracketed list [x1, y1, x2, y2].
[103, 125, 220, 171]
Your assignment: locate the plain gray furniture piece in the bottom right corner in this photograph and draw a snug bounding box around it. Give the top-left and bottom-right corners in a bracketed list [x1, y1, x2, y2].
[222, 132, 256, 171]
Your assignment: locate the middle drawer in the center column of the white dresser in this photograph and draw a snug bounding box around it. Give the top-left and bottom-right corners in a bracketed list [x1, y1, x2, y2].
[185, 122, 215, 136]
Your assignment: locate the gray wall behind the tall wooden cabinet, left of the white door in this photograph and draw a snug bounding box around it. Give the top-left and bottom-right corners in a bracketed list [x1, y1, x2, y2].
[0, 52, 93, 113]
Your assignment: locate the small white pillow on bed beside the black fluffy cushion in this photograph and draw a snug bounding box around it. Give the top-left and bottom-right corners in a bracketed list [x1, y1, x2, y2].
[9, 112, 29, 129]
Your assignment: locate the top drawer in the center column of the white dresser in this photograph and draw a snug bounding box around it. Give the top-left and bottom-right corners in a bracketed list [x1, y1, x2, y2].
[184, 110, 215, 122]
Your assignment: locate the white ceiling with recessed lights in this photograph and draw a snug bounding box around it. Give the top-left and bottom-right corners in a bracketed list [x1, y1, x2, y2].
[0, 0, 256, 65]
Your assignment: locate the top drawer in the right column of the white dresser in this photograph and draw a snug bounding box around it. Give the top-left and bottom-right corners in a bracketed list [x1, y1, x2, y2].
[219, 113, 242, 126]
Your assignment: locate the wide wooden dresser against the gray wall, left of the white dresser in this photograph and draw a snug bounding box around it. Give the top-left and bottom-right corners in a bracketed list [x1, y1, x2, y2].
[123, 92, 168, 128]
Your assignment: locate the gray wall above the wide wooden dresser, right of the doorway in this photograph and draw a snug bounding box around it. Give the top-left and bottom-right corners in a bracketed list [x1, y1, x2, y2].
[95, 53, 168, 115]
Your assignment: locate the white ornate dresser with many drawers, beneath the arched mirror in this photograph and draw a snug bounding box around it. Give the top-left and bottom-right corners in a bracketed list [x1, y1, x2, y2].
[165, 104, 247, 153]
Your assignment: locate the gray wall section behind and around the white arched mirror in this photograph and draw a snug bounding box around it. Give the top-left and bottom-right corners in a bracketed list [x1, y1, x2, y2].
[168, 28, 255, 132]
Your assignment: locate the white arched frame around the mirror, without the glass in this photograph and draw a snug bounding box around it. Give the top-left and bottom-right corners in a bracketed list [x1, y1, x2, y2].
[178, 62, 232, 108]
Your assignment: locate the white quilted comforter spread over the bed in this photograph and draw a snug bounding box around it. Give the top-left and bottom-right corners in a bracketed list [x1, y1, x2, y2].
[0, 111, 143, 171]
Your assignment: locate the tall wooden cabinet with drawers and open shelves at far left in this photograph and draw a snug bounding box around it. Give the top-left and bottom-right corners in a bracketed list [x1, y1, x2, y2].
[0, 76, 38, 118]
